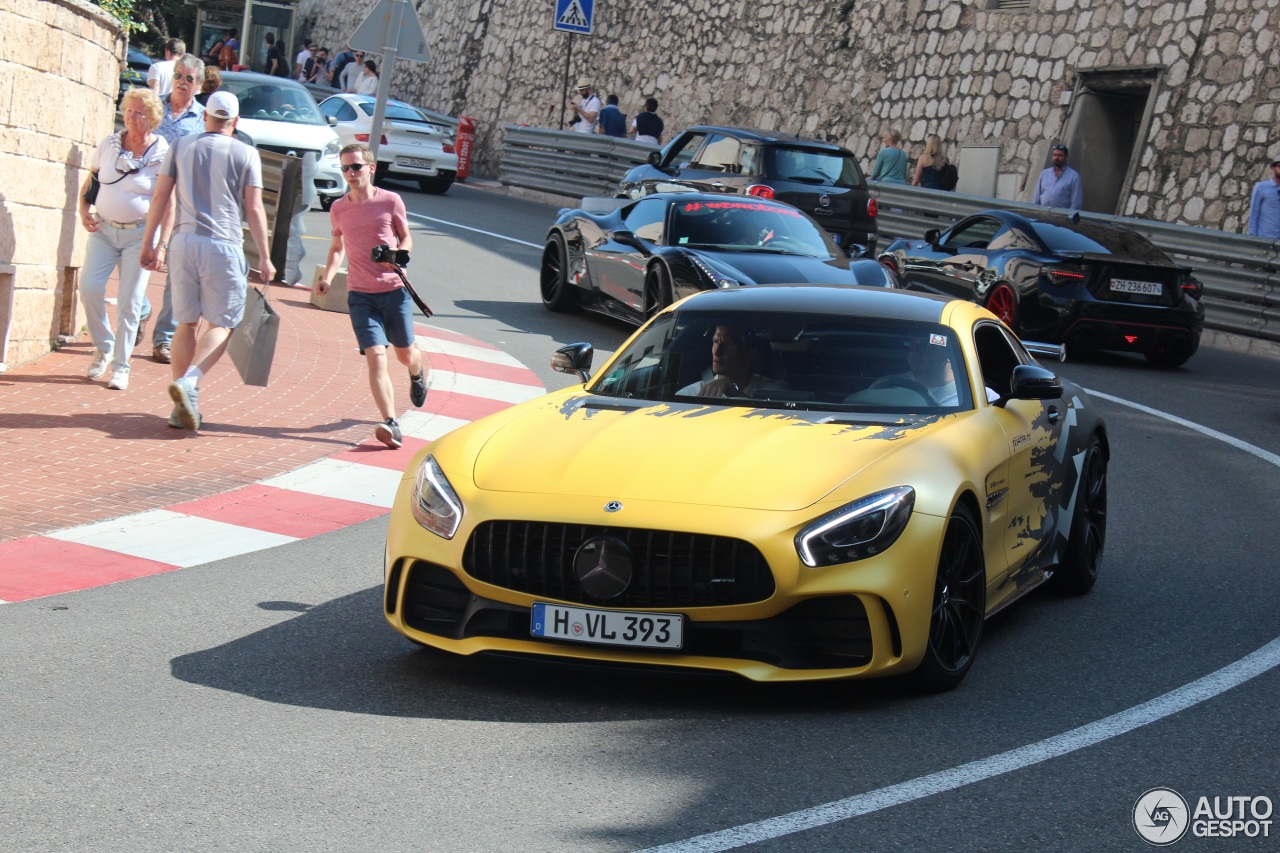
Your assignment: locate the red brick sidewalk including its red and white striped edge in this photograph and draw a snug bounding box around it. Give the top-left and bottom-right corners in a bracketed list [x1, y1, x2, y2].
[0, 262, 541, 601]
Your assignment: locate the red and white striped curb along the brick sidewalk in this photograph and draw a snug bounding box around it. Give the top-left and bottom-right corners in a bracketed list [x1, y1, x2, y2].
[0, 325, 544, 603]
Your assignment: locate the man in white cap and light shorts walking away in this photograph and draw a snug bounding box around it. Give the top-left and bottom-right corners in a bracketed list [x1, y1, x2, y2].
[142, 91, 275, 429]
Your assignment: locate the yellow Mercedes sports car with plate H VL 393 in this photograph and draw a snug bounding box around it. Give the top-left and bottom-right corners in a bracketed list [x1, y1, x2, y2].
[384, 286, 1108, 689]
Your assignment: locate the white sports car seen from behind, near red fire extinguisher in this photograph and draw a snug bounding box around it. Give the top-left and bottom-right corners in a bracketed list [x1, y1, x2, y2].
[320, 93, 458, 193]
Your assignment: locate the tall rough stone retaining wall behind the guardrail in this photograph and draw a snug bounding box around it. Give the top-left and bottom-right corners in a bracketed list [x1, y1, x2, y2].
[297, 0, 1280, 231]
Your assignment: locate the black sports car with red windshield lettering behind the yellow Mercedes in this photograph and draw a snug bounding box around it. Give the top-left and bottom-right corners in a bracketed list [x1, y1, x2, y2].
[541, 192, 897, 323]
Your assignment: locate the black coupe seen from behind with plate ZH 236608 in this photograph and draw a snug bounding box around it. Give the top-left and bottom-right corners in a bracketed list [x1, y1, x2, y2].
[879, 210, 1204, 368]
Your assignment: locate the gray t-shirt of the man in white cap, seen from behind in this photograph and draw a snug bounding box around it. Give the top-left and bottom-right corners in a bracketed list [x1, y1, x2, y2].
[160, 133, 262, 243]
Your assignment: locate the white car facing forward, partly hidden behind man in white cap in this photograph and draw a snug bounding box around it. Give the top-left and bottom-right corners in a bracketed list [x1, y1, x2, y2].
[223, 72, 347, 210]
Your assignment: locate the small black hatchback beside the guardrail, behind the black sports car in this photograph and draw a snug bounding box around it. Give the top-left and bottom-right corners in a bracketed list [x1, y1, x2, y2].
[618, 126, 877, 257]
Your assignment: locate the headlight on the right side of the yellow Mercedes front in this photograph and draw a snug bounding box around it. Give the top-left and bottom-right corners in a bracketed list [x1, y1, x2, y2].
[795, 485, 915, 567]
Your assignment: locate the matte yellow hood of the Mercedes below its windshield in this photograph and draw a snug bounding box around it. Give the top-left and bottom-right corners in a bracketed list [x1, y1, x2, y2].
[472, 393, 946, 511]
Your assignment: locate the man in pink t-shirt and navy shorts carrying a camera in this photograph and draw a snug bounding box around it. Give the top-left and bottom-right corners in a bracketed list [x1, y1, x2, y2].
[316, 142, 426, 450]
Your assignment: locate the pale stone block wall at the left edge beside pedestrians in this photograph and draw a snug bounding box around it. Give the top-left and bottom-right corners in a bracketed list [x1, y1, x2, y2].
[0, 0, 124, 370]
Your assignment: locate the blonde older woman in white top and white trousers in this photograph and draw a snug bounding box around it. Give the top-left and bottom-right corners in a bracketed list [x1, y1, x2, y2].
[79, 88, 169, 391]
